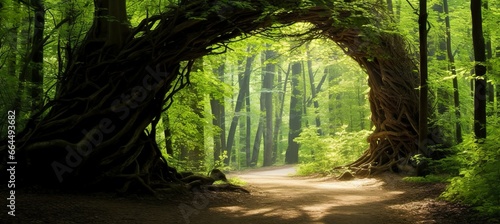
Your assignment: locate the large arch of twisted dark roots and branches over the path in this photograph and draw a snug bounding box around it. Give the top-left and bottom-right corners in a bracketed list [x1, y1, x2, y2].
[1, 0, 418, 191]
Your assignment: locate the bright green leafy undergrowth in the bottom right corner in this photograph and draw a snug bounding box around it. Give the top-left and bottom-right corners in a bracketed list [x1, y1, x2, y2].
[441, 118, 500, 217]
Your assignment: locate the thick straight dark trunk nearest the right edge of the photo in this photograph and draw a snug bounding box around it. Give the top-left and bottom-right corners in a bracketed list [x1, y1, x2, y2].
[470, 0, 486, 139]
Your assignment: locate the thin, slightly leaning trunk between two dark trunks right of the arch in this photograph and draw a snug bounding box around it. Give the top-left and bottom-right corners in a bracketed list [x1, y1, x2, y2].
[443, 0, 463, 143]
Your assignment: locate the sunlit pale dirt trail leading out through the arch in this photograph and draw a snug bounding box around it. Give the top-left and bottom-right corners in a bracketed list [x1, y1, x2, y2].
[222, 166, 406, 224]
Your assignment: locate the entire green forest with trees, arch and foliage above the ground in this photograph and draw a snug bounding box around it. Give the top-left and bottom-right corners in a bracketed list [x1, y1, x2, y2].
[0, 0, 500, 221]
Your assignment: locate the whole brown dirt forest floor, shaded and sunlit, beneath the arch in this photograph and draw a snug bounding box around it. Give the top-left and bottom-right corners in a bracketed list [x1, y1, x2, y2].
[0, 166, 493, 224]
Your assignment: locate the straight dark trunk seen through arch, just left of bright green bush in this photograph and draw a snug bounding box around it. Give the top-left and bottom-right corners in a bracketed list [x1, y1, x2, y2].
[285, 62, 302, 164]
